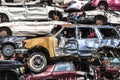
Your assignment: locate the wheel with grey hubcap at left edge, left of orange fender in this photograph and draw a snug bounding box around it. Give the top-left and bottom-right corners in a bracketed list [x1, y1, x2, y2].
[2, 45, 15, 57]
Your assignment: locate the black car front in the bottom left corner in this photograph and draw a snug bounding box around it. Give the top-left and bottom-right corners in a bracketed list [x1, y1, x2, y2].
[0, 60, 25, 80]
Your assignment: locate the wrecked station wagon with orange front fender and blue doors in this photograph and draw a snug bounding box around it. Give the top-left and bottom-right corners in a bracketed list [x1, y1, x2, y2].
[0, 24, 120, 72]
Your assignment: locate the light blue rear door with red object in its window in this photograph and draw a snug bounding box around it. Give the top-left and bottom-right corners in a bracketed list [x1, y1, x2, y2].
[78, 27, 100, 53]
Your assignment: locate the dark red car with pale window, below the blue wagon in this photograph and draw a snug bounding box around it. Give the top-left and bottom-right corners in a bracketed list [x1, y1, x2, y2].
[25, 62, 76, 80]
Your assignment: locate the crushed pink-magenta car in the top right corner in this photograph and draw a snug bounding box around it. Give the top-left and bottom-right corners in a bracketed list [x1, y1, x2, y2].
[86, 0, 120, 10]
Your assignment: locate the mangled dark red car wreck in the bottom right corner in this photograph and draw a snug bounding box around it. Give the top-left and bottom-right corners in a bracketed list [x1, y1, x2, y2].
[88, 57, 120, 80]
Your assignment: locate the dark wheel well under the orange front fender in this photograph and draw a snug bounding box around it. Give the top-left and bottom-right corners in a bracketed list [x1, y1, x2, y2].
[28, 47, 50, 61]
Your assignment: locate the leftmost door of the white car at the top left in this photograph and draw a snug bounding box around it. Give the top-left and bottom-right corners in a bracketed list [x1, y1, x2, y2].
[0, 0, 26, 20]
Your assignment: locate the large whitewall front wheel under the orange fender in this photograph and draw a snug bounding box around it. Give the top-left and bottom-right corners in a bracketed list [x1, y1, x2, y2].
[28, 52, 47, 72]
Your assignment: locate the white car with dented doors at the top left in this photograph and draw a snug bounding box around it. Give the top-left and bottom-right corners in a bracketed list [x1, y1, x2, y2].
[0, 0, 67, 22]
